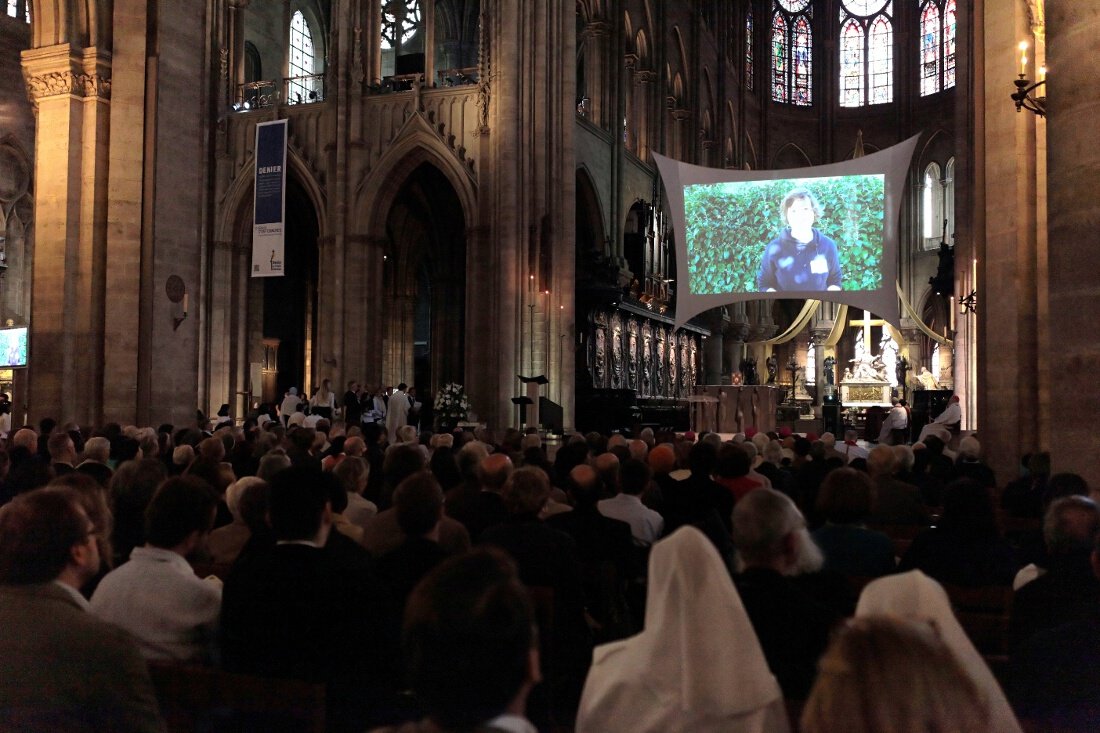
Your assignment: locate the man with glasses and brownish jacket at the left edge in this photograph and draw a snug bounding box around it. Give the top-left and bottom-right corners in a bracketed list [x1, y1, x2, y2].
[0, 489, 165, 733]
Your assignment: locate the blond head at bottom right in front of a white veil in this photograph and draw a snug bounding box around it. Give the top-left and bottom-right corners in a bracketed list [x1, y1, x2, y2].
[802, 616, 991, 733]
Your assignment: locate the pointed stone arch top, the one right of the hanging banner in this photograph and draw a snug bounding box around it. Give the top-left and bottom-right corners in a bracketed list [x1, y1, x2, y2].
[350, 112, 477, 239]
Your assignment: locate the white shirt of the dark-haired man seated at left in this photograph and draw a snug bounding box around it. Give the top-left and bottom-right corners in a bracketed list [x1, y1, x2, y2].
[91, 547, 221, 661]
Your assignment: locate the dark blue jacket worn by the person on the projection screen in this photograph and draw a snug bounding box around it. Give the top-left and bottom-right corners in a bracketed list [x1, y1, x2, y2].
[757, 227, 843, 291]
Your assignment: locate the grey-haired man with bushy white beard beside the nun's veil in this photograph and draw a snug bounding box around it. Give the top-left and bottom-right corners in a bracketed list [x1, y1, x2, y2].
[733, 489, 842, 700]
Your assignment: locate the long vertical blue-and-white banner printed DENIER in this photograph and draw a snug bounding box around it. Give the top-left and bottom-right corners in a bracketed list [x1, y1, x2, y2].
[252, 120, 287, 277]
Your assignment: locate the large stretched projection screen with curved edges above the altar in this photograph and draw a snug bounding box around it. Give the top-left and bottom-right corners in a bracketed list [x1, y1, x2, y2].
[653, 135, 917, 326]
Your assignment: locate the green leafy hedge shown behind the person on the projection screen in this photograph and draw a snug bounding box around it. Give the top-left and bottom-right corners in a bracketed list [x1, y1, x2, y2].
[684, 175, 886, 295]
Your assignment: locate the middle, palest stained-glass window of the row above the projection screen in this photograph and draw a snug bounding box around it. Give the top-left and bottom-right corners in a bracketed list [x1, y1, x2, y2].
[839, 0, 893, 107]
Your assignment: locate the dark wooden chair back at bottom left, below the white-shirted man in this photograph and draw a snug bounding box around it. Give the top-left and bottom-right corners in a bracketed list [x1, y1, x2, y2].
[149, 661, 325, 733]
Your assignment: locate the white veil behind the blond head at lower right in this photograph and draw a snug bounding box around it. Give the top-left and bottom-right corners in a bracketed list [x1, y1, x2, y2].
[856, 570, 1021, 733]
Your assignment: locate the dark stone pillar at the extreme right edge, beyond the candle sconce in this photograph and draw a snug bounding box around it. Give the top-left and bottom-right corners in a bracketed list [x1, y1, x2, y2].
[1038, 0, 1100, 486]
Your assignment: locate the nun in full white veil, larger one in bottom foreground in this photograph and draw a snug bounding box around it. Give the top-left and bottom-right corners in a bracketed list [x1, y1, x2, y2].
[576, 526, 790, 733]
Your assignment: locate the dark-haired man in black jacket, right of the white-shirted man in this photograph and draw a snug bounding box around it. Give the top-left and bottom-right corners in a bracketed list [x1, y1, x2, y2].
[221, 467, 397, 731]
